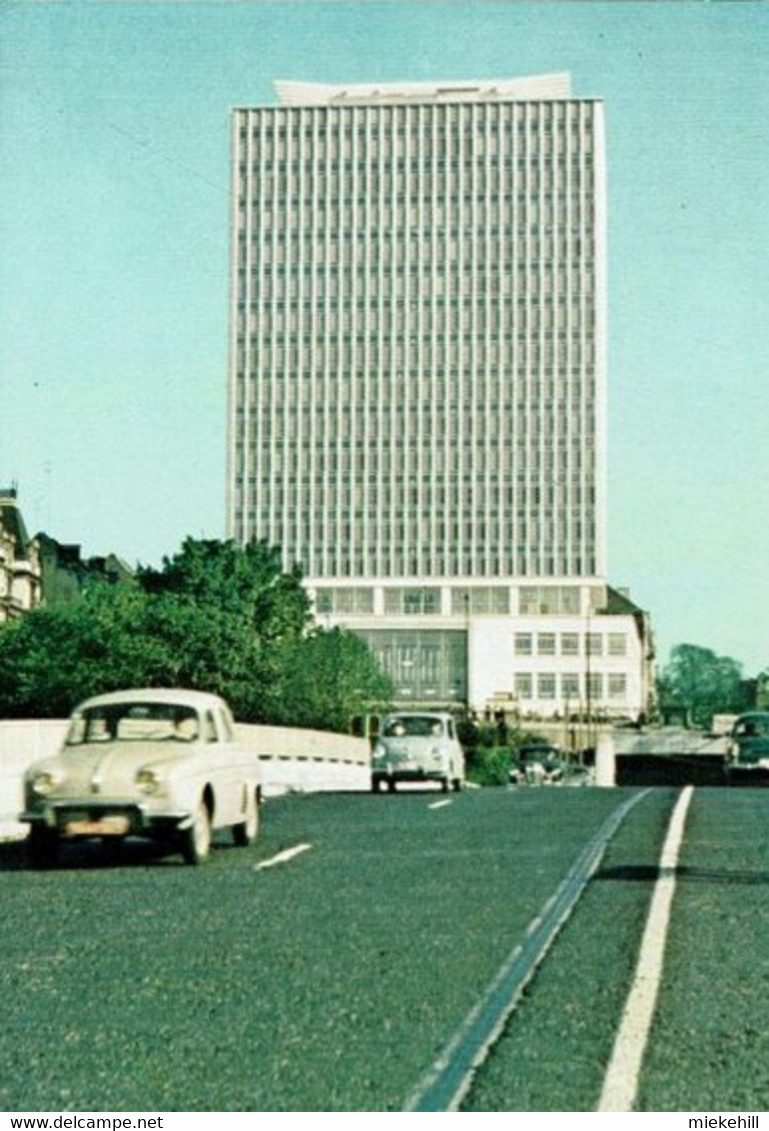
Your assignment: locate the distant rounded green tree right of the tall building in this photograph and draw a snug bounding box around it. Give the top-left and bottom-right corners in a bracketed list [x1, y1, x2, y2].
[658, 644, 744, 726]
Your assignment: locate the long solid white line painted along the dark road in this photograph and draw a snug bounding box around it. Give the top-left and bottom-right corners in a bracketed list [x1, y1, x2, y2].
[598, 785, 693, 1112]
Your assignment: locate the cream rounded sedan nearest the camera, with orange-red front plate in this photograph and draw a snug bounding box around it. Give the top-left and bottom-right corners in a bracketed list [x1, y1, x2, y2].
[19, 689, 261, 864]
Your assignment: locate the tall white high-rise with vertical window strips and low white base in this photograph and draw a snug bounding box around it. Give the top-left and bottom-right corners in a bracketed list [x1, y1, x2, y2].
[227, 75, 650, 716]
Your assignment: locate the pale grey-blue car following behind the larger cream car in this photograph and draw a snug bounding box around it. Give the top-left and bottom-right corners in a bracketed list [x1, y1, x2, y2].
[371, 711, 465, 793]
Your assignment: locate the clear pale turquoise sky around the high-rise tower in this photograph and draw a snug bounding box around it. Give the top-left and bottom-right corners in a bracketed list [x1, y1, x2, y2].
[0, 0, 769, 676]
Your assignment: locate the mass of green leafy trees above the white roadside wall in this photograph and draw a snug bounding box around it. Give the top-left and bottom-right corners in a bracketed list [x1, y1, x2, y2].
[0, 538, 388, 728]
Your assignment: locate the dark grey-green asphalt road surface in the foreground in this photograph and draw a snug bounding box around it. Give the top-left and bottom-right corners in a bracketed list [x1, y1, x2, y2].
[0, 788, 769, 1112]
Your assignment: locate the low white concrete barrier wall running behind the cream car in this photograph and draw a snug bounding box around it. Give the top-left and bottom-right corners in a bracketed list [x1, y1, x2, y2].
[0, 719, 370, 839]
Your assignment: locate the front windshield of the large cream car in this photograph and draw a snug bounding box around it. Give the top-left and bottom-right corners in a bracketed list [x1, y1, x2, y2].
[67, 702, 198, 746]
